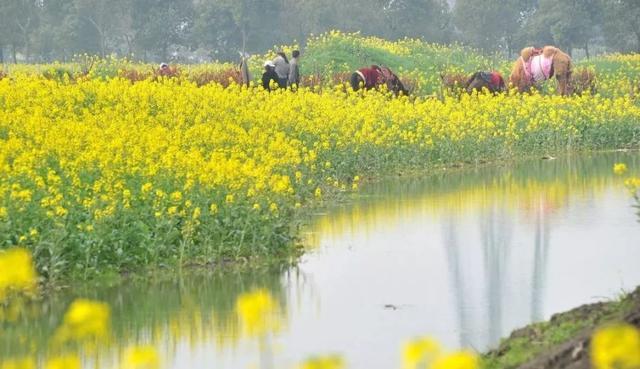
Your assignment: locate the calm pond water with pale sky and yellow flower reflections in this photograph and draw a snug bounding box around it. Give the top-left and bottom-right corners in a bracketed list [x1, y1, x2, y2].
[0, 154, 640, 369]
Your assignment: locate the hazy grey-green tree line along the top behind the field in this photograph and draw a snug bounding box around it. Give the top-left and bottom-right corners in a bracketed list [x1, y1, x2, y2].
[0, 0, 640, 62]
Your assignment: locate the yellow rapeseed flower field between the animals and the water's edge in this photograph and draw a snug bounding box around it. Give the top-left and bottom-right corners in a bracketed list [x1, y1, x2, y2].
[0, 75, 640, 278]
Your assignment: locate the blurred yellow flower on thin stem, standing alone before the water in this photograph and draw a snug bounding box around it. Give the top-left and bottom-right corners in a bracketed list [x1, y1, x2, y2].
[236, 290, 280, 337]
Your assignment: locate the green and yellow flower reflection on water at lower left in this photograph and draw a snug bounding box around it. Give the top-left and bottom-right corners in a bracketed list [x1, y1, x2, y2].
[0, 268, 295, 368]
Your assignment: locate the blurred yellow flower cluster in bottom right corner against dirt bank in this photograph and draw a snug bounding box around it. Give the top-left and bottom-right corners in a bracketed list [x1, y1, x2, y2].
[591, 325, 640, 369]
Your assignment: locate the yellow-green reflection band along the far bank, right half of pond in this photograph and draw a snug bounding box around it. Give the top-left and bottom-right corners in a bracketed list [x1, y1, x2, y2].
[305, 155, 638, 247]
